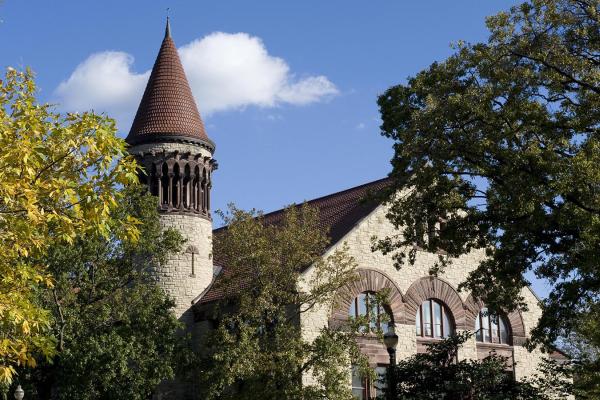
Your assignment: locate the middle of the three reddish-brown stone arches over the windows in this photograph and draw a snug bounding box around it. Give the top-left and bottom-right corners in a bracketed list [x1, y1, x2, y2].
[402, 276, 466, 329]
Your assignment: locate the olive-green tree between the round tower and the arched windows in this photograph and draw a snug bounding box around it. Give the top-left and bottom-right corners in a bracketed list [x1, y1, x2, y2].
[199, 206, 371, 400]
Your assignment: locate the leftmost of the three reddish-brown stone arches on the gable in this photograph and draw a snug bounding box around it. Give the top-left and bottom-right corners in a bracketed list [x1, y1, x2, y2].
[329, 268, 404, 326]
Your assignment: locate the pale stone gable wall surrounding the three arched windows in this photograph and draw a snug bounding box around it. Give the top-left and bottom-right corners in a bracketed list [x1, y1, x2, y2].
[301, 206, 541, 383]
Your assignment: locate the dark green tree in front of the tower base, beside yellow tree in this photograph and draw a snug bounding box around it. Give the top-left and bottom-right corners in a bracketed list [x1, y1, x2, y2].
[20, 186, 186, 400]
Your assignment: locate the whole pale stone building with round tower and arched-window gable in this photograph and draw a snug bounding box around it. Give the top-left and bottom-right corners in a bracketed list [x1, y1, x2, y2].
[126, 22, 556, 398]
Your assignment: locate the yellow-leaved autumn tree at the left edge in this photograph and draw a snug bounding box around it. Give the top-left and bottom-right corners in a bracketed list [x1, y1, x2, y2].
[0, 68, 138, 387]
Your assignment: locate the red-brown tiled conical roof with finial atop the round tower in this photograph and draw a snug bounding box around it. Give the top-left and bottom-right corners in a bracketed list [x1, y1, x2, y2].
[125, 18, 214, 148]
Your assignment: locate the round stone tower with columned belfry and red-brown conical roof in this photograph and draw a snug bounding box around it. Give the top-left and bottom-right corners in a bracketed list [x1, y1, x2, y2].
[125, 19, 217, 329]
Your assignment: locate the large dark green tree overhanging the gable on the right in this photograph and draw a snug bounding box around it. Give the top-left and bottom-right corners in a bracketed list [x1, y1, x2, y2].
[374, 0, 600, 341]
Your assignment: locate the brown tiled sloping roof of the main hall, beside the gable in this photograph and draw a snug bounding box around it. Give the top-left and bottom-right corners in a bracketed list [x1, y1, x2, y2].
[194, 178, 391, 304]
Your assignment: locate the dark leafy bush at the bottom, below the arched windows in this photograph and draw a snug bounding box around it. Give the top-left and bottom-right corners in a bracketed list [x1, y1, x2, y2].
[387, 332, 569, 400]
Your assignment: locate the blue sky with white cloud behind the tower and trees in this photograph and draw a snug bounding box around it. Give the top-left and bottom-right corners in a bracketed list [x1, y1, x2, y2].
[0, 0, 546, 294]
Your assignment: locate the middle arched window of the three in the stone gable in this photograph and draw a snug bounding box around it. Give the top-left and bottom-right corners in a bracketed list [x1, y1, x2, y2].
[415, 299, 454, 339]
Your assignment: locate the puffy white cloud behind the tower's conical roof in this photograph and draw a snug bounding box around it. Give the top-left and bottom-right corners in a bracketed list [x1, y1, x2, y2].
[55, 32, 338, 129]
